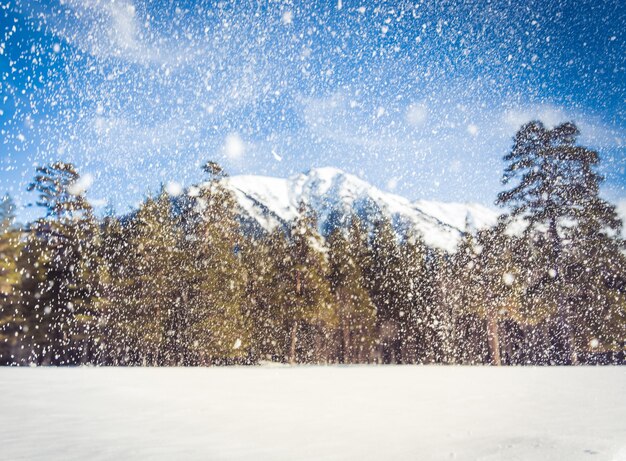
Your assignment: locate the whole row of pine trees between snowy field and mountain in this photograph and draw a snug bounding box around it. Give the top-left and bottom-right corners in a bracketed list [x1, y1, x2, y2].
[0, 122, 626, 366]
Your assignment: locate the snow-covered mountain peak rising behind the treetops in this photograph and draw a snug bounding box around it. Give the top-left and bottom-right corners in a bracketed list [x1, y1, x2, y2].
[219, 168, 498, 252]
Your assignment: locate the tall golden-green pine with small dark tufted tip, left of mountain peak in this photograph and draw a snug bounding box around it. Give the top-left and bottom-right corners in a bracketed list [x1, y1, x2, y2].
[183, 162, 251, 364]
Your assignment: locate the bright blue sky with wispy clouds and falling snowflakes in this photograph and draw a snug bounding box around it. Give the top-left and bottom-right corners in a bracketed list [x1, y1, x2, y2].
[0, 0, 626, 219]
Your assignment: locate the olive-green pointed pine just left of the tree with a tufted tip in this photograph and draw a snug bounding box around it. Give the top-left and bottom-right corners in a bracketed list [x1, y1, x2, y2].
[107, 191, 180, 365]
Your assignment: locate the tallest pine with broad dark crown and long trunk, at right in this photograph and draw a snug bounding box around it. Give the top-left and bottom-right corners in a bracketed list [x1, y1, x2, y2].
[497, 122, 621, 364]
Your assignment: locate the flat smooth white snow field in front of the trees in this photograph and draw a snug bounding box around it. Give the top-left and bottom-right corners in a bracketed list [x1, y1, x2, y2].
[0, 366, 626, 461]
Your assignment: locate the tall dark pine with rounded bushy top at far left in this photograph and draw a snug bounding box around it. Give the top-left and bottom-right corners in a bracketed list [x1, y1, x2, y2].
[27, 162, 99, 365]
